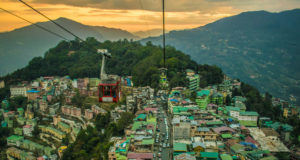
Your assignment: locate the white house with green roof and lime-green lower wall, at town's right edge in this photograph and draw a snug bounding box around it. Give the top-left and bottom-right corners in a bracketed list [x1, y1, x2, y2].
[238, 111, 259, 127]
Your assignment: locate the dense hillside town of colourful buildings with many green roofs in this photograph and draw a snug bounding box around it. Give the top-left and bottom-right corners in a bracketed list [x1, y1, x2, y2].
[0, 69, 300, 160]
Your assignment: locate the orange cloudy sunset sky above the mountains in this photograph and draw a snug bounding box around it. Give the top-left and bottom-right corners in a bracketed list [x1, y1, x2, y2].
[0, 0, 300, 32]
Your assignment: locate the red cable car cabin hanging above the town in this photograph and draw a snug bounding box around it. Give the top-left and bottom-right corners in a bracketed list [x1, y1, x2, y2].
[98, 81, 120, 102]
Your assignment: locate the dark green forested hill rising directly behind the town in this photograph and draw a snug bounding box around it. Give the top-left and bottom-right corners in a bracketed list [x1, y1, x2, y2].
[0, 37, 224, 88]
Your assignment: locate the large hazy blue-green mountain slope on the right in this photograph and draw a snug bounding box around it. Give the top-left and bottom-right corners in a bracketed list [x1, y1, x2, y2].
[142, 9, 300, 104]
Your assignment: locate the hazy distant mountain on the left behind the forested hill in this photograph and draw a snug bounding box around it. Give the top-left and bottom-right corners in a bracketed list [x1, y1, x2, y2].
[0, 18, 138, 76]
